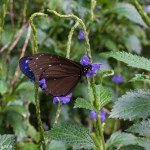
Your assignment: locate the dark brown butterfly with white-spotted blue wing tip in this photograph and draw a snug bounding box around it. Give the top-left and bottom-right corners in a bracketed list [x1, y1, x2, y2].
[19, 53, 92, 97]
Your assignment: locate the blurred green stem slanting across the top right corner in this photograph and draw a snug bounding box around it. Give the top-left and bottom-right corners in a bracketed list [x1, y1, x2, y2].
[131, 0, 150, 28]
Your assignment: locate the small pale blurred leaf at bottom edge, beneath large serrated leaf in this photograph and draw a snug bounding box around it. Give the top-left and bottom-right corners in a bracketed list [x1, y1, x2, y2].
[48, 140, 66, 150]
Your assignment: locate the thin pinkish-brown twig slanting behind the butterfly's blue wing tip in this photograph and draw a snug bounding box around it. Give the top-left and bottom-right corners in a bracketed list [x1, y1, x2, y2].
[10, 25, 31, 90]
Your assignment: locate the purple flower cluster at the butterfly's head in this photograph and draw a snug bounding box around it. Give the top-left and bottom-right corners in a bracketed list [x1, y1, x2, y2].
[80, 55, 103, 78]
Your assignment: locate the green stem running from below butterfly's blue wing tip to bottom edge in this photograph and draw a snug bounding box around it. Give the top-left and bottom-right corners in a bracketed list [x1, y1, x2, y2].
[34, 80, 46, 150]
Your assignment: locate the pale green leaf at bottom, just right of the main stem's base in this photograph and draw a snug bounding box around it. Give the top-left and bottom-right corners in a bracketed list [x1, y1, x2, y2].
[106, 132, 136, 150]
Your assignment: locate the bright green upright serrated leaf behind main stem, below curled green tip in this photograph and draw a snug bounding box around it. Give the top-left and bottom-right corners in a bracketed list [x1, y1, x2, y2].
[89, 85, 111, 109]
